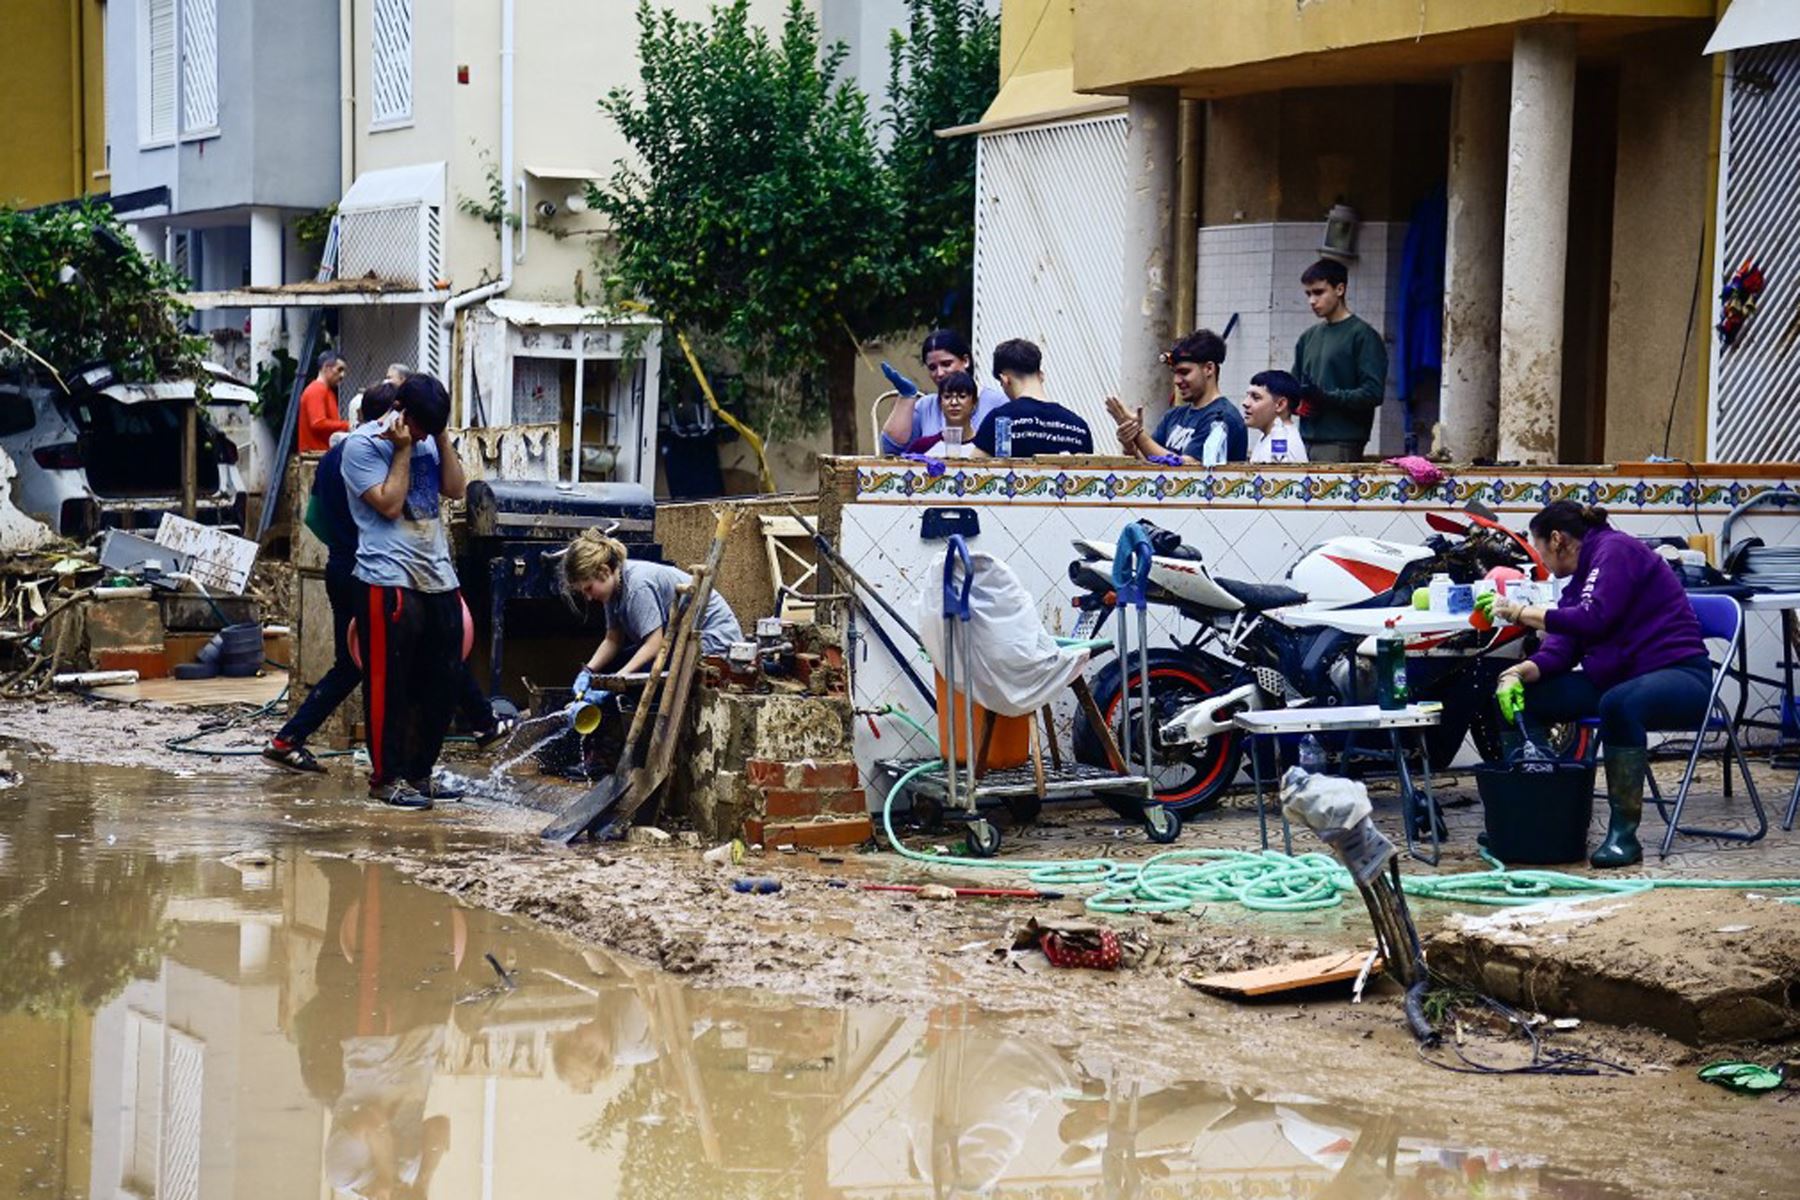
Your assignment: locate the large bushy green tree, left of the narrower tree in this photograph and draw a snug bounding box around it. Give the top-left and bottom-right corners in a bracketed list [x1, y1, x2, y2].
[589, 0, 896, 435]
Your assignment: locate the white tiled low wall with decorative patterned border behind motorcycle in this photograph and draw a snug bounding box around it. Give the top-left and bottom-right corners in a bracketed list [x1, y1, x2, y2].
[839, 461, 1800, 799]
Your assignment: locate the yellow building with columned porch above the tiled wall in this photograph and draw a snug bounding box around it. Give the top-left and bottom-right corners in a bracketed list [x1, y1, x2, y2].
[976, 0, 1749, 462]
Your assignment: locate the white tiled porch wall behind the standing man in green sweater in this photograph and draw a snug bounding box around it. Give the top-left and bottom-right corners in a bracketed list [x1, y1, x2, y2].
[1193, 221, 1426, 455]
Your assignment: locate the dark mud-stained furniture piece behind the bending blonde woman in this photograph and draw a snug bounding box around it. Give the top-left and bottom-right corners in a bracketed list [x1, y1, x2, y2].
[463, 479, 662, 694]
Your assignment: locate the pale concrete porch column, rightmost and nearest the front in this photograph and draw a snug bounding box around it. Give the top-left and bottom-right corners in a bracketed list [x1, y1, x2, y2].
[1499, 25, 1575, 462]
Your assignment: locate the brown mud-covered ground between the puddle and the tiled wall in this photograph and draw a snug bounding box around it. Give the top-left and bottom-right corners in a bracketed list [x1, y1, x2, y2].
[10, 683, 1800, 1196]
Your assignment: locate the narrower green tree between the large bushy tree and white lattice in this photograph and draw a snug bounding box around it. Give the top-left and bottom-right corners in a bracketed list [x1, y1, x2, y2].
[877, 0, 1001, 333]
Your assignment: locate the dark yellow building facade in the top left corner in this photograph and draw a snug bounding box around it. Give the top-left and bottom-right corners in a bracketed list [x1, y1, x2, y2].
[0, 0, 108, 207]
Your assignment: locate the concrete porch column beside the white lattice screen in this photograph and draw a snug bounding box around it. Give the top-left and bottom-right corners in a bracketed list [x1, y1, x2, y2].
[1100, 88, 1181, 417]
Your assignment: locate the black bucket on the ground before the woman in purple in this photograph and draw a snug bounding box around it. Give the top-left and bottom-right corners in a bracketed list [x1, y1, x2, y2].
[1474, 759, 1593, 867]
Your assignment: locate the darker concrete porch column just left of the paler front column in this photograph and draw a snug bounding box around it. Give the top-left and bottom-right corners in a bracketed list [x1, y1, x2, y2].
[1438, 63, 1508, 462]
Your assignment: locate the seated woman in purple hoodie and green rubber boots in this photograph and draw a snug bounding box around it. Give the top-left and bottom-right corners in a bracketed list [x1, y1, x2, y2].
[1481, 500, 1712, 867]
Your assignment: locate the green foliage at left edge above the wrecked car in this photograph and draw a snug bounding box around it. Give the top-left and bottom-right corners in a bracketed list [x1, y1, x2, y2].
[0, 200, 207, 387]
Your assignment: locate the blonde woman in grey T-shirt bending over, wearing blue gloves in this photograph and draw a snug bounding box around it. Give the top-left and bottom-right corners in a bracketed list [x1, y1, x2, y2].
[563, 529, 743, 696]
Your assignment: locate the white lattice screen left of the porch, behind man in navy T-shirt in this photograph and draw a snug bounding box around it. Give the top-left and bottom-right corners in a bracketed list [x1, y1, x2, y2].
[974, 113, 1125, 438]
